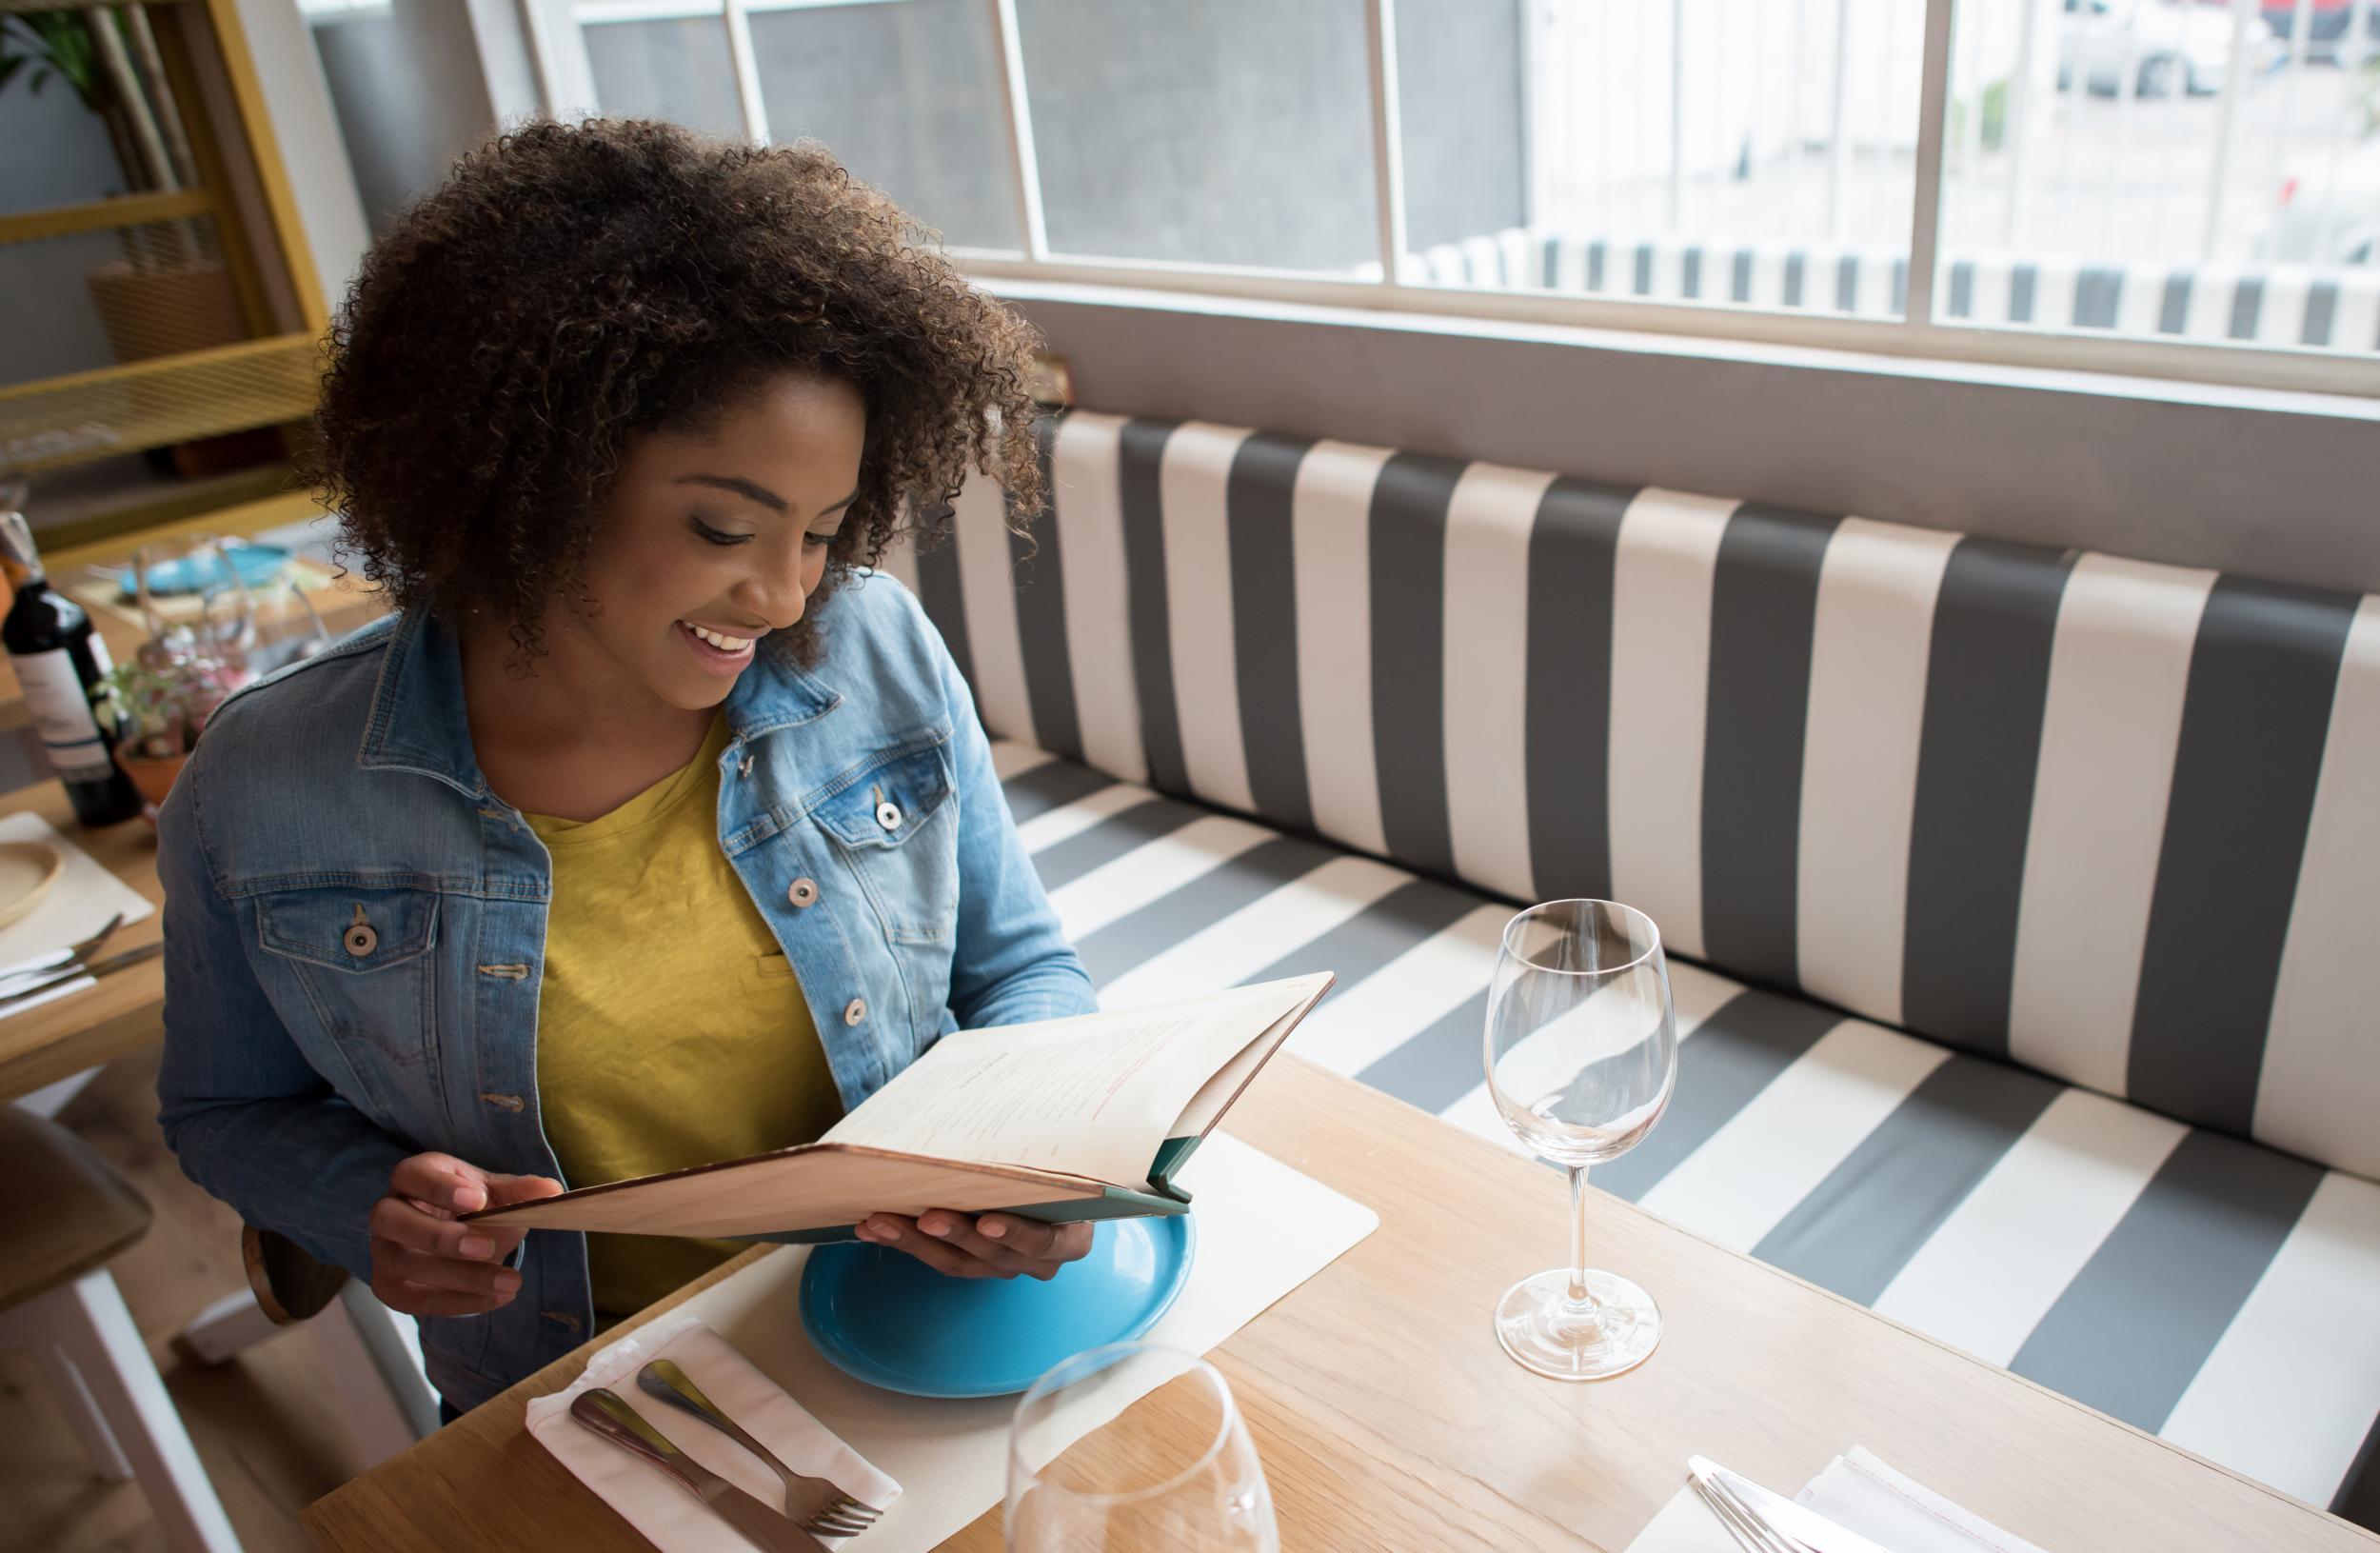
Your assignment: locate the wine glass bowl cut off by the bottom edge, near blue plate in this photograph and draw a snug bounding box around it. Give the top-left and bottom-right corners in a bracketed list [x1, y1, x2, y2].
[1004, 1344, 1280, 1553]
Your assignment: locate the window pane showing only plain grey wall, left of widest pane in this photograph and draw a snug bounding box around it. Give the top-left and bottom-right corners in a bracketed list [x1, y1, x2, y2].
[1017, 0, 1380, 271]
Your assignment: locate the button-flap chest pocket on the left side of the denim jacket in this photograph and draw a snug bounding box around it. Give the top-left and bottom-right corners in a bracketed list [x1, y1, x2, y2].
[257, 886, 441, 1110]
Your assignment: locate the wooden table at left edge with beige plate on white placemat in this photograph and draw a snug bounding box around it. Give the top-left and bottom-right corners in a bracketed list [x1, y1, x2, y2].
[0, 782, 165, 1103]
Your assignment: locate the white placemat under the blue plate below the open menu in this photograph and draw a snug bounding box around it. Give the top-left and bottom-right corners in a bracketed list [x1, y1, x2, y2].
[587, 1134, 1380, 1553]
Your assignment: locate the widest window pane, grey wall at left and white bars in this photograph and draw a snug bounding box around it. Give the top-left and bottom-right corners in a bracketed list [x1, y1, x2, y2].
[1398, 0, 1923, 319]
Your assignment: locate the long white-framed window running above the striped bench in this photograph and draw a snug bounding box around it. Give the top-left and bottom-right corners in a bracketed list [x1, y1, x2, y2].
[533, 0, 2380, 393]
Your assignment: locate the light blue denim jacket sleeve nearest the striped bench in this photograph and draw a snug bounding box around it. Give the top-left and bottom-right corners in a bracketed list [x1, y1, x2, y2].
[912, 605, 1100, 1029]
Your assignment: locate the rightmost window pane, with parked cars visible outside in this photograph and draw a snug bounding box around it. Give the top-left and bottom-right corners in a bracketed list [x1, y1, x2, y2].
[1935, 0, 2380, 352]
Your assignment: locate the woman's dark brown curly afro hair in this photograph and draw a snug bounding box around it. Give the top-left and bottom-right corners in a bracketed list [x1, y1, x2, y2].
[307, 119, 1042, 662]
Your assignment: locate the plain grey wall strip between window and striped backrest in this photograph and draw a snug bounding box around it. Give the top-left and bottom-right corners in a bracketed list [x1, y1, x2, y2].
[1002, 284, 2380, 593]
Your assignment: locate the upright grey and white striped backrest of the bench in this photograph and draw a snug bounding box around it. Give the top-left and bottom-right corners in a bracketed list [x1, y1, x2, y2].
[895, 412, 2380, 1177]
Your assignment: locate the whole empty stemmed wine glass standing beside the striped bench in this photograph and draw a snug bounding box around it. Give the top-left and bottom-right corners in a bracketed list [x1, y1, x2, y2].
[1488, 901, 1678, 1382]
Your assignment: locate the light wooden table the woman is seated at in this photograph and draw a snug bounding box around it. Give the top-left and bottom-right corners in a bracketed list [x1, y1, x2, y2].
[305, 1058, 2380, 1553]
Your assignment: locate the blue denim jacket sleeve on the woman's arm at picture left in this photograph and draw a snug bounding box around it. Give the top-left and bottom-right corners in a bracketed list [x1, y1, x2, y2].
[157, 760, 417, 1282]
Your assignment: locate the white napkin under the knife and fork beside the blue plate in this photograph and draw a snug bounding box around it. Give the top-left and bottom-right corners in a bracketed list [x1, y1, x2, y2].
[528, 1312, 900, 1553]
